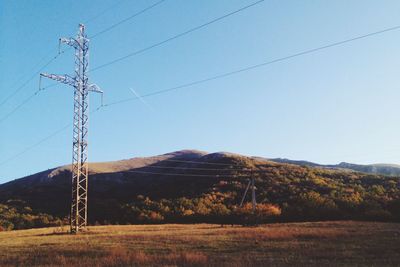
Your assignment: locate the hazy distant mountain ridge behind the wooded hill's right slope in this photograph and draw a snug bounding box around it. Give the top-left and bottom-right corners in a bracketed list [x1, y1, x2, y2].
[269, 158, 400, 176]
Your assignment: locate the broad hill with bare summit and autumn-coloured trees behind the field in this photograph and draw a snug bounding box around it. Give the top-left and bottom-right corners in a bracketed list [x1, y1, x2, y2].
[0, 150, 400, 229]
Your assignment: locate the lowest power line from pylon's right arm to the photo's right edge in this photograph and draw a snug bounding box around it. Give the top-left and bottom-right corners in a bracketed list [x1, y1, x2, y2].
[104, 25, 400, 106]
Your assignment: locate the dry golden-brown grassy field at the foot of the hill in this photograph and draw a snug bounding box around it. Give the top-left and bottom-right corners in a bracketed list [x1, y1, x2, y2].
[0, 222, 400, 267]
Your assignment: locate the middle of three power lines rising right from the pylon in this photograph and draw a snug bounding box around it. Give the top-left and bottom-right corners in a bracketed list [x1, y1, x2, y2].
[91, 0, 265, 71]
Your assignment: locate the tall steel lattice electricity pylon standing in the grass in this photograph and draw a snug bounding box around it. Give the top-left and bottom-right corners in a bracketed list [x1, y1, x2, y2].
[40, 24, 103, 233]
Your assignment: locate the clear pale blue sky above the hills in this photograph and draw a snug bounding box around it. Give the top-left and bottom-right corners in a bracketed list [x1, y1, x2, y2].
[0, 0, 400, 183]
